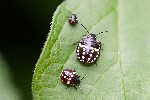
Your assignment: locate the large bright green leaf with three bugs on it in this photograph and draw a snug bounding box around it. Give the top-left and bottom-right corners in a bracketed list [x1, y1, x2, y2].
[32, 0, 150, 100]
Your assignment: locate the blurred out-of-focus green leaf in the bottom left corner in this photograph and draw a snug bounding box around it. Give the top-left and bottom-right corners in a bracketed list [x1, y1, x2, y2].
[0, 53, 21, 100]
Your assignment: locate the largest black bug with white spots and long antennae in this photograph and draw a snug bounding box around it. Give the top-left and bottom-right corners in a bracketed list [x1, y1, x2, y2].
[76, 24, 108, 64]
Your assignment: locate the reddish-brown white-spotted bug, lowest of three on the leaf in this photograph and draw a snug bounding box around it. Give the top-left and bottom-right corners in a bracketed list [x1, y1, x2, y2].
[60, 68, 84, 90]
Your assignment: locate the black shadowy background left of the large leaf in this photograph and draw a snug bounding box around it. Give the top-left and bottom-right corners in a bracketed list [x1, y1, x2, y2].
[0, 0, 62, 100]
